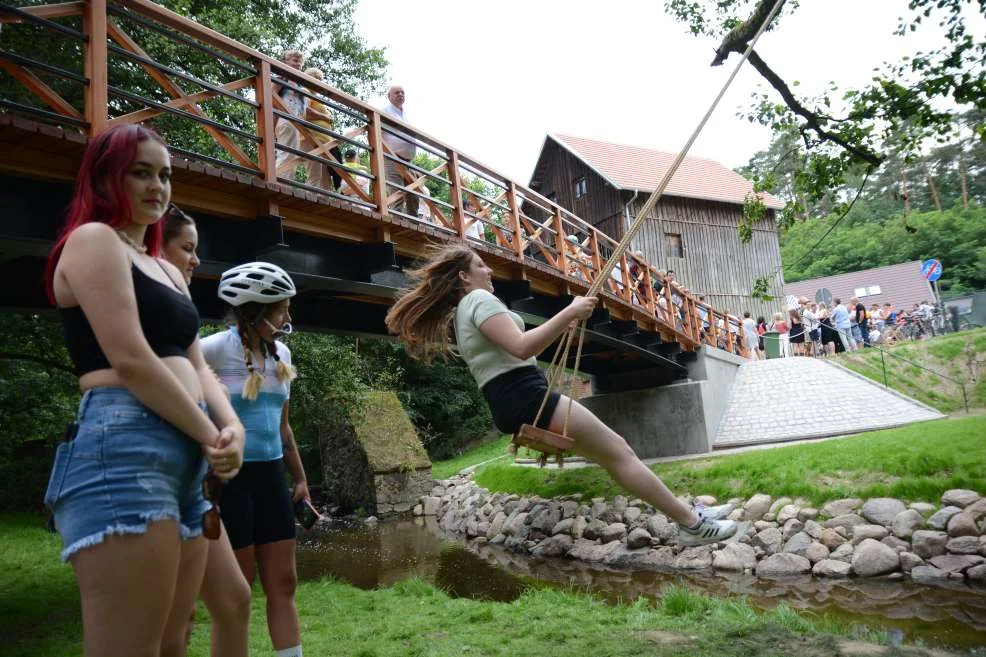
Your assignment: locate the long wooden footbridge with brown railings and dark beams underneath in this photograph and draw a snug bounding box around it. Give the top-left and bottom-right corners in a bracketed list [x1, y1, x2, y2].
[0, 0, 745, 389]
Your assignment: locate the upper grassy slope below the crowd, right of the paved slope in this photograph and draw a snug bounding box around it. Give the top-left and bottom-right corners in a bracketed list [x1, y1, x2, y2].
[836, 329, 986, 413]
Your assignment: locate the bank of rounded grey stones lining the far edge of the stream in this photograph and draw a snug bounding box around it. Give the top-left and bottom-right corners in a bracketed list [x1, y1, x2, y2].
[413, 475, 986, 585]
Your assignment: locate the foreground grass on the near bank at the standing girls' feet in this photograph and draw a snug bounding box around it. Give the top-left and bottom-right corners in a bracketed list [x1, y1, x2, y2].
[0, 515, 888, 657]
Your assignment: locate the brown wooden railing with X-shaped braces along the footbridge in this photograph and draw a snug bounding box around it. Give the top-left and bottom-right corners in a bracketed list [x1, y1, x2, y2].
[0, 0, 745, 353]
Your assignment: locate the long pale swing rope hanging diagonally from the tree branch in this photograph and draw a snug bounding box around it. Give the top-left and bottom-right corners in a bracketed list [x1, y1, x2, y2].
[534, 0, 784, 437]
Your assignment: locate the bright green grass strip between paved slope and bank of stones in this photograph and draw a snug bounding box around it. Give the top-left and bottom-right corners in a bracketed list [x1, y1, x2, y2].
[475, 416, 986, 504]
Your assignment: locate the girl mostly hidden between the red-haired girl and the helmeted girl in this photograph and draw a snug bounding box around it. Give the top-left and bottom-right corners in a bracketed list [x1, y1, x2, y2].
[162, 203, 250, 657]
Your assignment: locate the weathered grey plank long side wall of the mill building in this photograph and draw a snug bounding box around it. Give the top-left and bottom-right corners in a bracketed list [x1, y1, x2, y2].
[624, 192, 784, 320]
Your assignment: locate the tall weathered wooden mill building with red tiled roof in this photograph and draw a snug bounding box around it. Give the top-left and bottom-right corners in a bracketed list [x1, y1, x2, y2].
[530, 134, 784, 318]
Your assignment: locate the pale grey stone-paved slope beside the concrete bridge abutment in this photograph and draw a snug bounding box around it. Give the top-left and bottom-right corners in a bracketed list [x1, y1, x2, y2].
[714, 357, 945, 448]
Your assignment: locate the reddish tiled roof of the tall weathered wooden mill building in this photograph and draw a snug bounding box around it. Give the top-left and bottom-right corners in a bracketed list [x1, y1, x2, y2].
[548, 134, 784, 210]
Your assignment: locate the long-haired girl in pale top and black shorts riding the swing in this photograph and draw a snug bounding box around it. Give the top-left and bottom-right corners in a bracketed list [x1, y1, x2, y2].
[386, 244, 738, 546]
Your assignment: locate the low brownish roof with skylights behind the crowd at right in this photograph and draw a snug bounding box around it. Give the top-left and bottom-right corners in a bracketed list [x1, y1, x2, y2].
[784, 260, 934, 310]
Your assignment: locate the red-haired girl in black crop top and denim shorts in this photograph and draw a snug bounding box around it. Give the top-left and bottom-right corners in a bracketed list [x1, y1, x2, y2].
[45, 125, 243, 657]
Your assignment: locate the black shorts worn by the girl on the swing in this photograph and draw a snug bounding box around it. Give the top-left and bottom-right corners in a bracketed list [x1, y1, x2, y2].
[483, 365, 561, 433]
